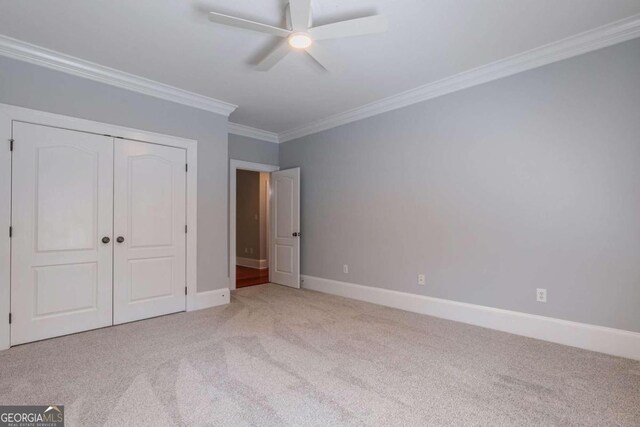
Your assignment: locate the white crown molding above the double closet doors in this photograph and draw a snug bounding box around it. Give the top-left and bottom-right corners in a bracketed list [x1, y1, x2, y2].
[0, 34, 238, 117]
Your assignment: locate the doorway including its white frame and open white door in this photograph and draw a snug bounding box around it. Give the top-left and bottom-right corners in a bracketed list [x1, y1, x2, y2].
[229, 160, 302, 290]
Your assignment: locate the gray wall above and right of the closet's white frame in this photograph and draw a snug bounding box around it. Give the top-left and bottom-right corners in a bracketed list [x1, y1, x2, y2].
[0, 57, 228, 291]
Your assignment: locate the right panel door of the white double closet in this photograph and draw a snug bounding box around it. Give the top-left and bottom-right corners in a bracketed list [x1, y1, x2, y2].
[113, 139, 187, 324]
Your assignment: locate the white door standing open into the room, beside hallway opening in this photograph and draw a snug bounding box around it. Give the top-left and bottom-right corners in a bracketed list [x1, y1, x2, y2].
[269, 168, 300, 288]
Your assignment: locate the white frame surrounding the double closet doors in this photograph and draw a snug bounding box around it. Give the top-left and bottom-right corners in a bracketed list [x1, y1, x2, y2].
[0, 103, 198, 350]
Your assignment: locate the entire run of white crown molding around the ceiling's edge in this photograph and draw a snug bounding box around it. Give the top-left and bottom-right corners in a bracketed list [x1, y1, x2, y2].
[0, 15, 640, 139]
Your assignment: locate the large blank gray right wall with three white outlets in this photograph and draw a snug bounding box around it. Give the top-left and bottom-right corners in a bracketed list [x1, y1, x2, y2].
[280, 40, 640, 331]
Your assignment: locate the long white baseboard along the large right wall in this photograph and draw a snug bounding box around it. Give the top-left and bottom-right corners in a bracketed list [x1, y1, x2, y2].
[302, 276, 640, 360]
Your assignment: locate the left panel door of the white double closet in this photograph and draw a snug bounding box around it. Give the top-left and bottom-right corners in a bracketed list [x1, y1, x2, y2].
[11, 122, 113, 345]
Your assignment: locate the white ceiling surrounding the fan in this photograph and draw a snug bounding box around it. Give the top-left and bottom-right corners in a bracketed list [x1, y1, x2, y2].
[0, 0, 640, 132]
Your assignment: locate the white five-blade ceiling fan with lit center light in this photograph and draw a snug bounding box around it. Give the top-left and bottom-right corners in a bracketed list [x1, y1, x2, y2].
[209, 0, 387, 71]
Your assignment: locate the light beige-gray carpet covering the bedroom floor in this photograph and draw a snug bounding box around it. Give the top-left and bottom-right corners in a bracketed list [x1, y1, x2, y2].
[0, 285, 640, 426]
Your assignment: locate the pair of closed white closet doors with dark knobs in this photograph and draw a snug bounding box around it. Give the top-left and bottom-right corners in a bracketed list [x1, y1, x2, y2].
[11, 122, 186, 345]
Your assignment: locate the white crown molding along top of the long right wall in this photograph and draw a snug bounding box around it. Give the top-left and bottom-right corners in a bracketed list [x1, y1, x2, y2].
[278, 15, 640, 142]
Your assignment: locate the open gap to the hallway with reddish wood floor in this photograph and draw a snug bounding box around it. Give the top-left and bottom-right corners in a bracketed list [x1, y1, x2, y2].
[235, 169, 271, 289]
